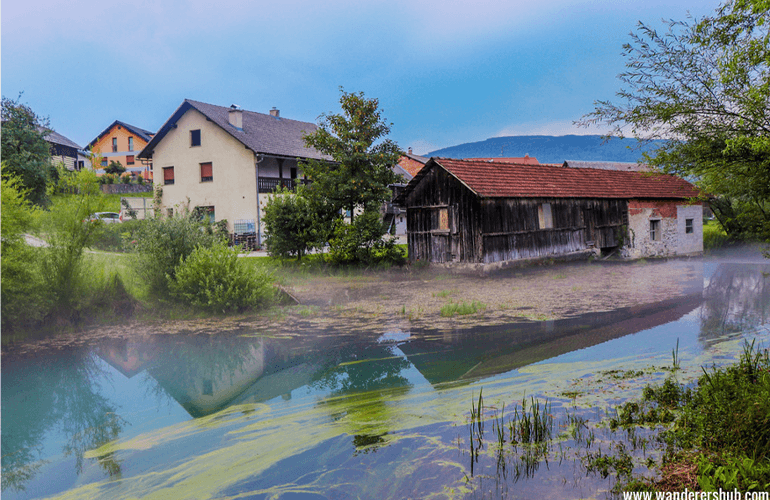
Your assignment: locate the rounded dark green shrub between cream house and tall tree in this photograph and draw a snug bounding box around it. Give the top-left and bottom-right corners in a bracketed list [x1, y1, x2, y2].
[262, 186, 316, 259]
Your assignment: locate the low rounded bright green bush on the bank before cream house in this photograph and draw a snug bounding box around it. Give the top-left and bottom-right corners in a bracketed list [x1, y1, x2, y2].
[169, 241, 275, 312]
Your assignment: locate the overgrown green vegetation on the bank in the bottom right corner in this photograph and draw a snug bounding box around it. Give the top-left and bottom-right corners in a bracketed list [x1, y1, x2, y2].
[610, 343, 770, 491]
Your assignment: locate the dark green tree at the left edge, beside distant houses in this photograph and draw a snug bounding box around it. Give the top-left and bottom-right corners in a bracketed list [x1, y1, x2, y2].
[2, 96, 53, 205]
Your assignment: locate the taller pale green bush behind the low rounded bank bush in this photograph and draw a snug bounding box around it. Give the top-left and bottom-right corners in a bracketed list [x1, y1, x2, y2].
[136, 210, 221, 296]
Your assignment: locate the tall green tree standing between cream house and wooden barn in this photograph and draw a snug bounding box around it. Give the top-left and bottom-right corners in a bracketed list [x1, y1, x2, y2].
[302, 88, 401, 223]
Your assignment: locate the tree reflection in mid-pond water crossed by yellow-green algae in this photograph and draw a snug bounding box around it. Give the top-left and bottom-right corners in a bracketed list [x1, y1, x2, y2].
[313, 346, 412, 453]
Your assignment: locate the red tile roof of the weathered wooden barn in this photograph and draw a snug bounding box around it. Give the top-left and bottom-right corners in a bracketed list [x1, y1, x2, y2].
[428, 158, 700, 199]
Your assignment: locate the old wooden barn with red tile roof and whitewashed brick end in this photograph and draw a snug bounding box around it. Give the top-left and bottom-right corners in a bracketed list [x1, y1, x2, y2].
[397, 158, 703, 263]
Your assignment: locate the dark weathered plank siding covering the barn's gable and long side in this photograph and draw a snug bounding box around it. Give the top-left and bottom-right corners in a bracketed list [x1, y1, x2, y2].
[405, 166, 628, 263]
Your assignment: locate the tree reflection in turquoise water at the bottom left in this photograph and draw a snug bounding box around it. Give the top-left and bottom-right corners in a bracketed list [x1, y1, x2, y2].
[2, 350, 124, 490]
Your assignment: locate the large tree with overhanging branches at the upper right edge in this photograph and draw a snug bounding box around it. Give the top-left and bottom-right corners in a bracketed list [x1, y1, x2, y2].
[579, 0, 770, 242]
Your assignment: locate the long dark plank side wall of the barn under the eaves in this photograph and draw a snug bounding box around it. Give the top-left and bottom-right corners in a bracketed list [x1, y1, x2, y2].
[481, 198, 627, 263]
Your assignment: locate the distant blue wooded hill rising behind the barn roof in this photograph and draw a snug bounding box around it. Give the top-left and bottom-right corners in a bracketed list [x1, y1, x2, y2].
[424, 135, 665, 163]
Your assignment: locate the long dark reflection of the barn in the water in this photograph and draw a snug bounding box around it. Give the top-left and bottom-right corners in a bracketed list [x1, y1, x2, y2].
[399, 266, 703, 385]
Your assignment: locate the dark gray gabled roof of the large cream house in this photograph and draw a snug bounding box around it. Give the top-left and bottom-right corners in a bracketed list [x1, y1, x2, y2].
[138, 99, 329, 160]
